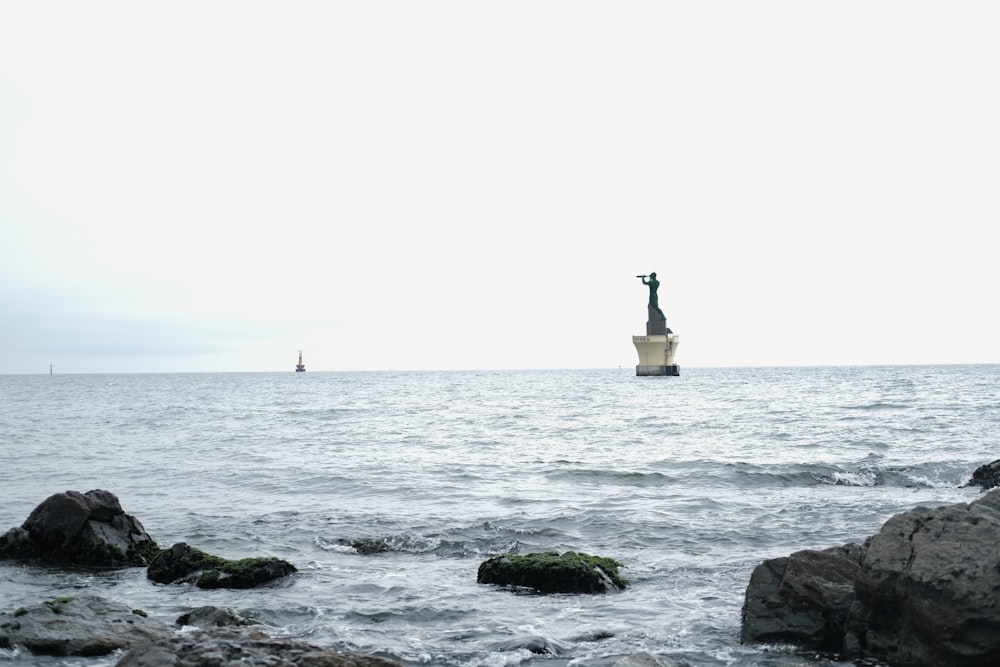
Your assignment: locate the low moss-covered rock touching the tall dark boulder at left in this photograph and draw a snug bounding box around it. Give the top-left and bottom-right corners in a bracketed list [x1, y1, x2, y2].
[146, 542, 297, 588]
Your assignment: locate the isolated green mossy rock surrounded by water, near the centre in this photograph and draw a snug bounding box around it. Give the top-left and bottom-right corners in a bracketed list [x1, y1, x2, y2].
[477, 551, 628, 593]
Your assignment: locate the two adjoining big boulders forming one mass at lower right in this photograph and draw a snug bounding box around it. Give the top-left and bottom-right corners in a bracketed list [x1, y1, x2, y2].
[742, 490, 1000, 667]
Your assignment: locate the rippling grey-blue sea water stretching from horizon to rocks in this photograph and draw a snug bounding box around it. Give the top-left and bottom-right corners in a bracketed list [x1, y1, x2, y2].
[0, 365, 1000, 667]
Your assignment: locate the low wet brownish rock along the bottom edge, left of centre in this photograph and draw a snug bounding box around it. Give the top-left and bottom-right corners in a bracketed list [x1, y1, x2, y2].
[115, 630, 399, 667]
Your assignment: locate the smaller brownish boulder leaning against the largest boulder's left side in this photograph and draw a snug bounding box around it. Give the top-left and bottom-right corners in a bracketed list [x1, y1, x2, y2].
[741, 544, 861, 651]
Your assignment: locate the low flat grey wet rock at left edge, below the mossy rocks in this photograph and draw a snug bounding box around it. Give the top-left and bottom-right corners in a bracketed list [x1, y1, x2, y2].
[0, 595, 171, 656]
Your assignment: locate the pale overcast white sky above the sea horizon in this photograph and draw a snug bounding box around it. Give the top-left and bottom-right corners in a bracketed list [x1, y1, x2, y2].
[0, 0, 1000, 373]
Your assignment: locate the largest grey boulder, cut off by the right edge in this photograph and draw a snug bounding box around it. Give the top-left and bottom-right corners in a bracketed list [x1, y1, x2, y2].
[854, 490, 1000, 666]
